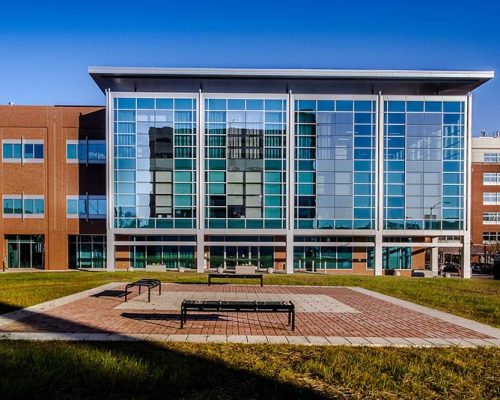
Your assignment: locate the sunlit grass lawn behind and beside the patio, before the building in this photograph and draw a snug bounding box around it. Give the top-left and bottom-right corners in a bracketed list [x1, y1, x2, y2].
[0, 271, 500, 327]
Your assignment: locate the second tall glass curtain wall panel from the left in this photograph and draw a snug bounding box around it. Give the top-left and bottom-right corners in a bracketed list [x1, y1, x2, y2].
[205, 98, 286, 229]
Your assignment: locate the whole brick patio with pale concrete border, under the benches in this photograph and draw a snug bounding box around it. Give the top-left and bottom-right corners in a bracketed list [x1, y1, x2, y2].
[0, 283, 500, 345]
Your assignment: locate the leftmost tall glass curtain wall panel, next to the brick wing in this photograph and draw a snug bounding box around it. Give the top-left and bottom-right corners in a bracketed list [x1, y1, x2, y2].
[114, 97, 196, 228]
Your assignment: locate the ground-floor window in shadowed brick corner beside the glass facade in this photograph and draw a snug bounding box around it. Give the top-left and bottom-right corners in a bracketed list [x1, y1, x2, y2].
[68, 235, 106, 269]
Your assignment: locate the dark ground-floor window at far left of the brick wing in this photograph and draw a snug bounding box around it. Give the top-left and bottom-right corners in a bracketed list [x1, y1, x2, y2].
[6, 235, 44, 269]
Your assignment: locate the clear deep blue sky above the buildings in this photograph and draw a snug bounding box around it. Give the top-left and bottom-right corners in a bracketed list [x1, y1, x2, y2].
[0, 0, 500, 134]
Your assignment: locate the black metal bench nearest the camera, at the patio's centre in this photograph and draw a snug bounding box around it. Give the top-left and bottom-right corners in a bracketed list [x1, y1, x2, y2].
[181, 299, 295, 331]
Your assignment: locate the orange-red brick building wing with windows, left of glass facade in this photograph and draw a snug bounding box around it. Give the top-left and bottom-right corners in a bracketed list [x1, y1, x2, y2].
[0, 106, 106, 270]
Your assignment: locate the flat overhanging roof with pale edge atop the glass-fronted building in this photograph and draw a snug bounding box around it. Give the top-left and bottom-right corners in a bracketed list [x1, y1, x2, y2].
[88, 67, 495, 95]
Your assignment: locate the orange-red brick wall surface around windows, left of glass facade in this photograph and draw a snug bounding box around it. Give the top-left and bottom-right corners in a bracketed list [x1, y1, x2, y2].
[0, 106, 106, 270]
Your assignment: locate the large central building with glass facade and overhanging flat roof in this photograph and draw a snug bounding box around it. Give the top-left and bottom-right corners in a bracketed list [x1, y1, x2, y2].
[90, 67, 496, 275]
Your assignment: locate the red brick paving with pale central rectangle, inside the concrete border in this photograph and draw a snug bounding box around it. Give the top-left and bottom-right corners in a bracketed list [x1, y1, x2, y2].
[0, 284, 491, 343]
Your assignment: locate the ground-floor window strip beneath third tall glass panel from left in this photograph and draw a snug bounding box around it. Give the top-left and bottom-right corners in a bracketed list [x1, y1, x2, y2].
[293, 246, 352, 272]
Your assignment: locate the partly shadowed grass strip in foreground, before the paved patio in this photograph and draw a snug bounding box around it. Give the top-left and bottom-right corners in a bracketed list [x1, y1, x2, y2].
[0, 342, 500, 400]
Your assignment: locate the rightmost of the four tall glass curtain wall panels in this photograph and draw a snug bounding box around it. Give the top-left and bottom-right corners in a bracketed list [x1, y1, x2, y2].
[384, 101, 465, 230]
